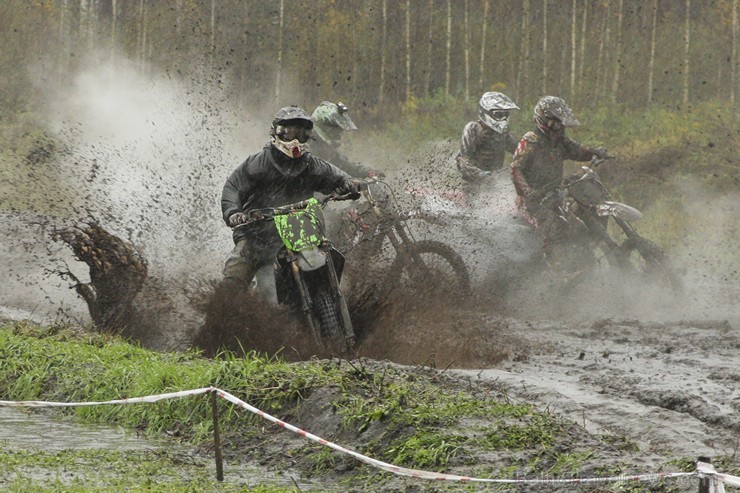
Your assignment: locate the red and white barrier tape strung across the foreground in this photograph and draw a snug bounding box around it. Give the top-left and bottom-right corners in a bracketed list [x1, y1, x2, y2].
[0, 387, 740, 493]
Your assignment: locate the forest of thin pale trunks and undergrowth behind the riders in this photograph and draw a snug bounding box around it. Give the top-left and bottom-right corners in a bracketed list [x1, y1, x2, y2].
[0, 0, 740, 258]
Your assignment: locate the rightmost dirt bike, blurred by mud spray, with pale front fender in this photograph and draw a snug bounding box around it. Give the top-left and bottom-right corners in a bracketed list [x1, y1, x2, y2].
[545, 156, 682, 290]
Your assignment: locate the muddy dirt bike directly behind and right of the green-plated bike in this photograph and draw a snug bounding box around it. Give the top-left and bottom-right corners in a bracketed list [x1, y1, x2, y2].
[345, 178, 470, 295]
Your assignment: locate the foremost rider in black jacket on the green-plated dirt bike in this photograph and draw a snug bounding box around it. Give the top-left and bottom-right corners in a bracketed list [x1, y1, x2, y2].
[221, 106, 362, 286]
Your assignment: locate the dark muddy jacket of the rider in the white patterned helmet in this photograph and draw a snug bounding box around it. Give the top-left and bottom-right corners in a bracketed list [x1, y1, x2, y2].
[455, 121, 516, 181]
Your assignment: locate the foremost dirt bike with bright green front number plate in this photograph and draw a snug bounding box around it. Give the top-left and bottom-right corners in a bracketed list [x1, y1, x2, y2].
[236, 193, 355, 354]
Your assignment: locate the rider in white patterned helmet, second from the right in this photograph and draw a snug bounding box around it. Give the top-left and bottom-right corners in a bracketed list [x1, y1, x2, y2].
[455, 92, 519, 191]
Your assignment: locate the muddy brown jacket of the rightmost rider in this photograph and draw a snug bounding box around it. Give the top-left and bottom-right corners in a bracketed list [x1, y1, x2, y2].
[511, 130, 594, 207]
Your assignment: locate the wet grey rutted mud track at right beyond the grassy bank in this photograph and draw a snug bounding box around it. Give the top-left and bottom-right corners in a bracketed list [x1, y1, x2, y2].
[456, 320, 740, 457]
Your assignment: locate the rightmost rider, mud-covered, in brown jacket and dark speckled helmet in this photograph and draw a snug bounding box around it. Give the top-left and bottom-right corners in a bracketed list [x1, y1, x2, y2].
[511, 96, 608, 259]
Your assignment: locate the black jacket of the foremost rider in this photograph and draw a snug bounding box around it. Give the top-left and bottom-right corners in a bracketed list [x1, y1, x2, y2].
[221, 143, 351, 243]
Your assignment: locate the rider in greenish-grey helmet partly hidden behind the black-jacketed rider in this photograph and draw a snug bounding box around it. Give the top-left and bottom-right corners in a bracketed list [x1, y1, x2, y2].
[311, 101, 385, 178]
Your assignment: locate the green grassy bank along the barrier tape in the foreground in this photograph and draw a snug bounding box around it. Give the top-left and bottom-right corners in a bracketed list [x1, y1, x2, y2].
[0, 322, 700, 493]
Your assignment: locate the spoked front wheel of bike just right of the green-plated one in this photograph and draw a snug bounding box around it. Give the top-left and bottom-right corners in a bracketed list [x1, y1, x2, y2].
[389, 240, 470, 295]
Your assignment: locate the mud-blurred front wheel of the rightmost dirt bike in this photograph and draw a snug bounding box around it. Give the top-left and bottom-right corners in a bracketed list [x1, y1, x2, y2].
[620, 236, 683, 293]
